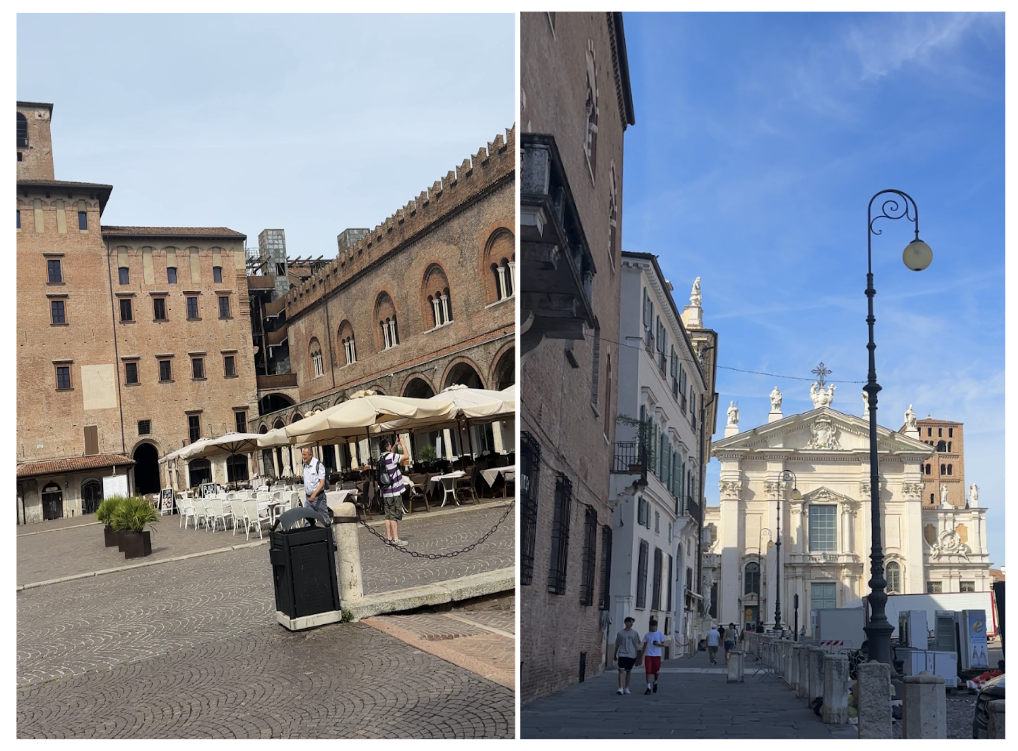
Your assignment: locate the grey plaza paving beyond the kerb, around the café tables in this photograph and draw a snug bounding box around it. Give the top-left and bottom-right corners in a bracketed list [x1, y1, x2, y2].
[17, 499, 515, 591]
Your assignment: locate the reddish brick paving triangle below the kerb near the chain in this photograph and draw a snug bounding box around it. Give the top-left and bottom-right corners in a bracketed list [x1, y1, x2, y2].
[364, 596, 516, 689]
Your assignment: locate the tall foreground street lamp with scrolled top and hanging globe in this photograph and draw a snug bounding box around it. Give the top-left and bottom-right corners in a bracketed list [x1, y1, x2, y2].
[863, 190, 934, 665]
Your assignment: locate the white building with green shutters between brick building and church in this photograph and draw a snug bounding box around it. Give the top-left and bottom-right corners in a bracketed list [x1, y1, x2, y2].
[611, 252, 718, 656]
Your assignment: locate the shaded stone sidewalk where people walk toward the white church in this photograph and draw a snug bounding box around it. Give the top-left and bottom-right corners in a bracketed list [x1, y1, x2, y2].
[520, 652, 857, 739]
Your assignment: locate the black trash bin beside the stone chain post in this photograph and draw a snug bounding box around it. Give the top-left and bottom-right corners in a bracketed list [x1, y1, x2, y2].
[269, 507, 342, 631]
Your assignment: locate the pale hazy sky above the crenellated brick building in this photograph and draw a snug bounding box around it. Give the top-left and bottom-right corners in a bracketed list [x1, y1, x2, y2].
[17, 13, 516, 257]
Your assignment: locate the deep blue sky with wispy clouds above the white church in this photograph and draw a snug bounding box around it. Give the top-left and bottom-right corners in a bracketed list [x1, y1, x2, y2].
[623, 13, 1005, 566]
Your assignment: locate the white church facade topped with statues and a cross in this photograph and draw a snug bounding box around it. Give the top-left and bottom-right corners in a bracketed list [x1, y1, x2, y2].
[703, 384, 991, 633]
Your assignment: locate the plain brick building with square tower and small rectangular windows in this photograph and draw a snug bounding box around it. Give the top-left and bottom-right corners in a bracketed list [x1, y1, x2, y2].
[16, 102, 257, 521]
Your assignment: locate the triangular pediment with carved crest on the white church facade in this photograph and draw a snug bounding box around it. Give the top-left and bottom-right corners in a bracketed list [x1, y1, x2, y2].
[712, 407, 932, 457]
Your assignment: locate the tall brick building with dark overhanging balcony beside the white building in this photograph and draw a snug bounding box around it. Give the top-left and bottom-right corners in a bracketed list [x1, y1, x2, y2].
[519, 13, 634, 701]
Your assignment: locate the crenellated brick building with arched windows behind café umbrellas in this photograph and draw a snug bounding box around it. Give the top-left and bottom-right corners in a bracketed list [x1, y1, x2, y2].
[248, 128, 516, 476]
